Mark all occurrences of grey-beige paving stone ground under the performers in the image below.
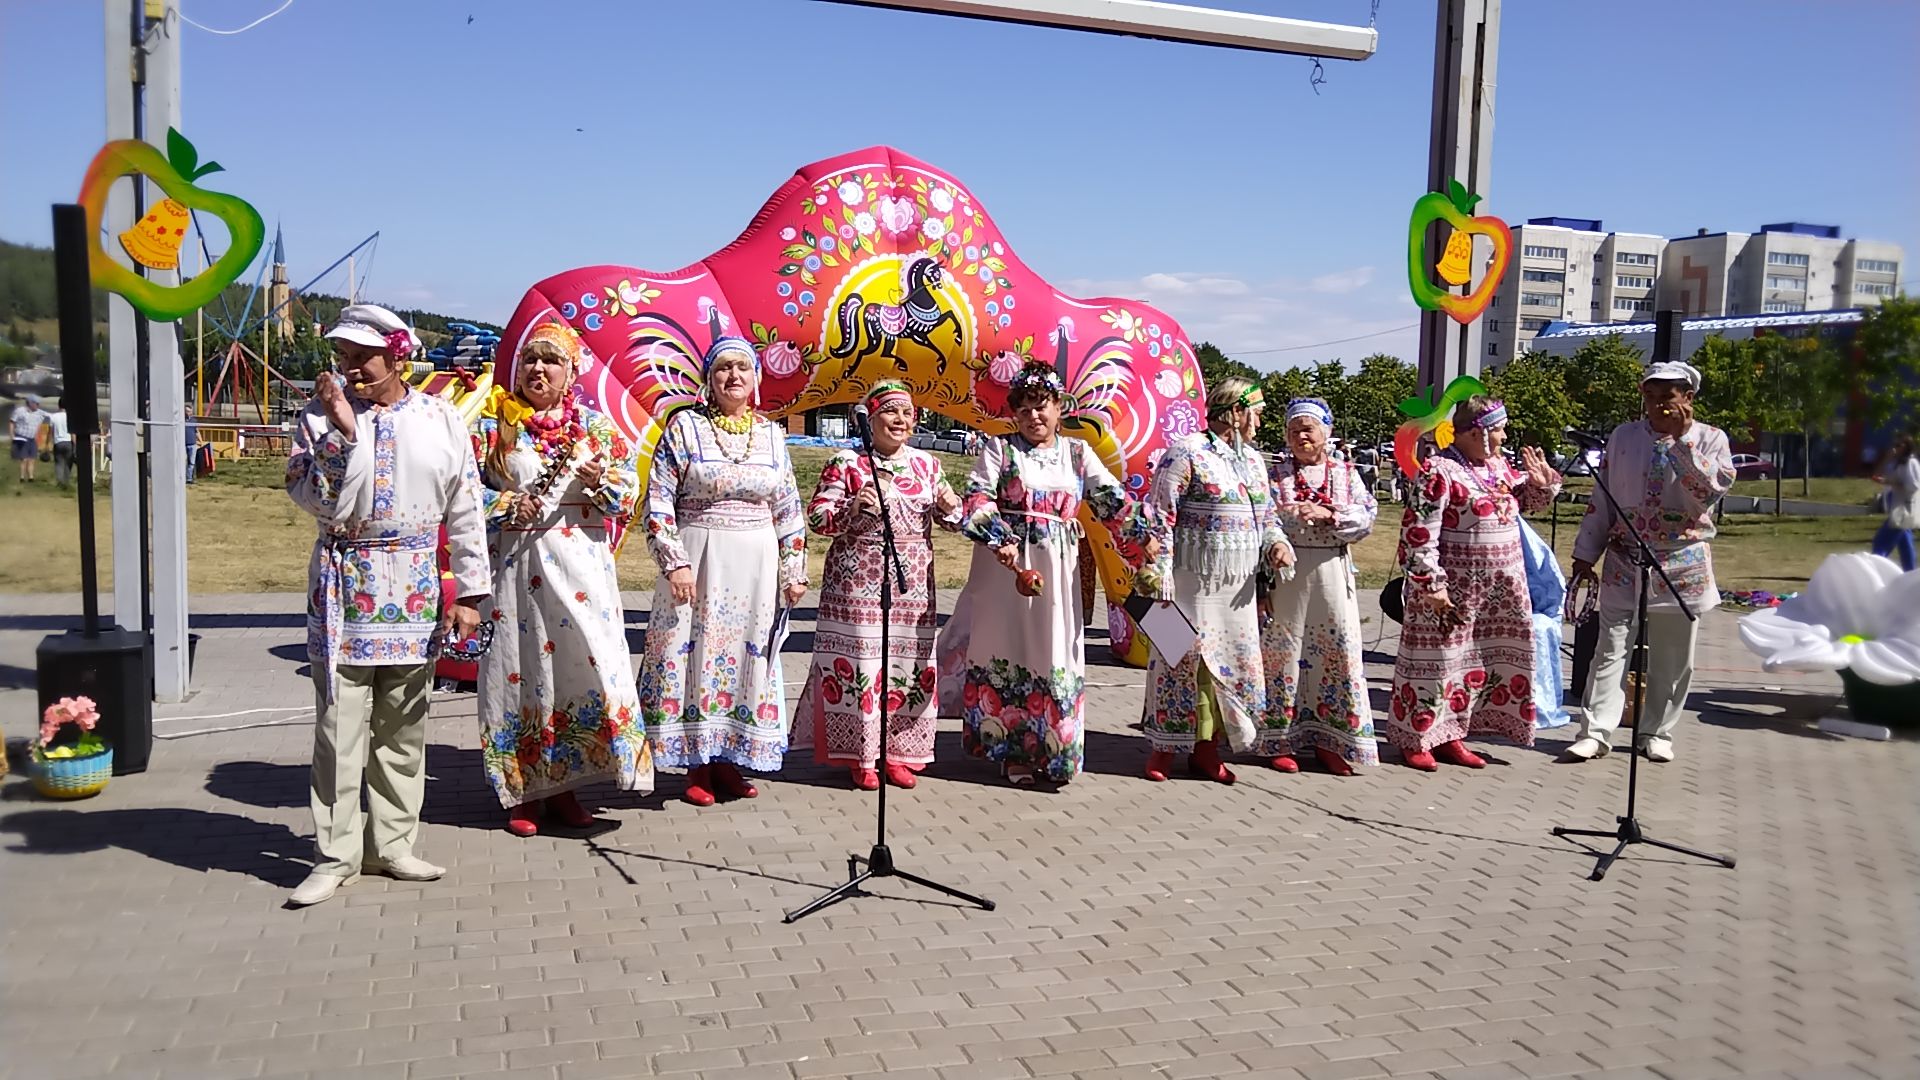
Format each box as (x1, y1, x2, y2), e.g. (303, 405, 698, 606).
(0, 596, 1920, 1080)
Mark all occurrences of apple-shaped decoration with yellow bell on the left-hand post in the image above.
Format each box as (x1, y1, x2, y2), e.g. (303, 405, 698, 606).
(81, 127, 267, 323)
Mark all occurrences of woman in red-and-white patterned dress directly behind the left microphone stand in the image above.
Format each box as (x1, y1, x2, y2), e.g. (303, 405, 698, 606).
(793, 380, 960, 792)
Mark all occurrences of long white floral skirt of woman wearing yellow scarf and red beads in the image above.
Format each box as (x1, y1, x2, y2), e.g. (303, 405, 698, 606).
(480, 525, 653, 807)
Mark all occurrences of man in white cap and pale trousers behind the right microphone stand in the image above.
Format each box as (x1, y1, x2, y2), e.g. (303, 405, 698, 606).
(1567, 361, 1734, 761)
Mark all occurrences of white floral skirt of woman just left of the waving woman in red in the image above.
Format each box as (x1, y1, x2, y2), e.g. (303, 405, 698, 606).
(1260, 548, 1380, 765)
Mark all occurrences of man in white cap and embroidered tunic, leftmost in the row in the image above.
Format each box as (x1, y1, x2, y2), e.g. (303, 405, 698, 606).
(286, 304, 493, 907)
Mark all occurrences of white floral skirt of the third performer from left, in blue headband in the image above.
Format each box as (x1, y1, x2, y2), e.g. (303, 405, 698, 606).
(639, 525, 787, 773)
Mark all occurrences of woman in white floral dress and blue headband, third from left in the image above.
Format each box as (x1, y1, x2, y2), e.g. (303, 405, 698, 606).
(639, 336, 806, 807)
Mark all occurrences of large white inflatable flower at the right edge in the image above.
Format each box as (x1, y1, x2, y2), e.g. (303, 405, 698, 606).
(1740, 555, 1920, 686)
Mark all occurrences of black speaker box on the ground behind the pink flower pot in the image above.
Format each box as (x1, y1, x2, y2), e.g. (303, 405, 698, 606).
(35, 626, 154, 776)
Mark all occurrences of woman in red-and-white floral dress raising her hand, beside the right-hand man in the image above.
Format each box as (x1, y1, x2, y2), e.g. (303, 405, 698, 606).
(1386, 394, 1561, 773)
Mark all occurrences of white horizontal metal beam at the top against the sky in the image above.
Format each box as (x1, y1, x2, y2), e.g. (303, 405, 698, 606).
(828, 0, 1380, 60)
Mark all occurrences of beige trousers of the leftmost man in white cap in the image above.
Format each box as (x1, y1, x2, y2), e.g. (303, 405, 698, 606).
(311, 663, 434, 876)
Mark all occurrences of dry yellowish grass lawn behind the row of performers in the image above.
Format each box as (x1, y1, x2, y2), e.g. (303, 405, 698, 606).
(0, 448, 1880, 592)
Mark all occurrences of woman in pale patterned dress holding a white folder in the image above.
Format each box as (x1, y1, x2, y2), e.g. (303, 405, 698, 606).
(1135, 377, 1294, 784)
